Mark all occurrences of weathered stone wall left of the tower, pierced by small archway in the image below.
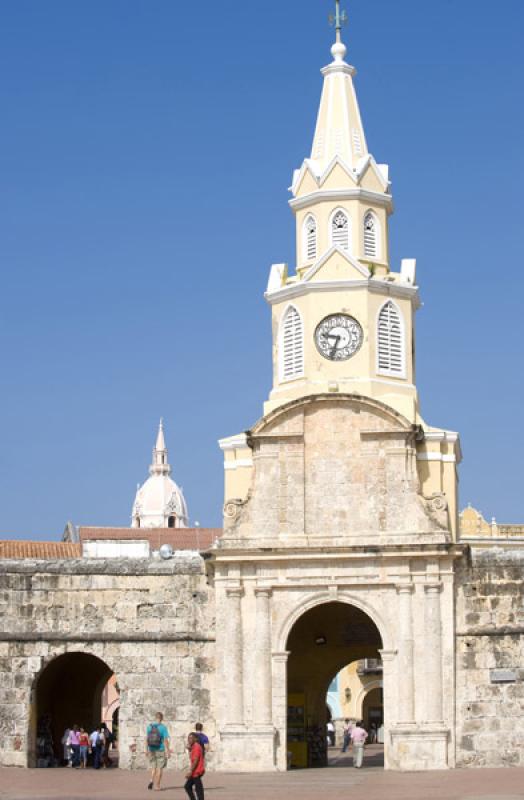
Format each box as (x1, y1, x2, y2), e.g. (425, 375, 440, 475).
(0, 554, 215, 768)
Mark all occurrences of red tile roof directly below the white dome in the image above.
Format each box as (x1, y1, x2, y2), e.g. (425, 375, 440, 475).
(79, 527, 222, 550)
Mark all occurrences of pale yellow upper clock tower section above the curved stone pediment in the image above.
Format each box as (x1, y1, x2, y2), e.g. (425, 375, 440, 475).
(264, 11, 419, 422)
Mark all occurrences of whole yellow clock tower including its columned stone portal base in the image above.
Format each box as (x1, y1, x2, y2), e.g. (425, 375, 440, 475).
(215, 0, 462, 770)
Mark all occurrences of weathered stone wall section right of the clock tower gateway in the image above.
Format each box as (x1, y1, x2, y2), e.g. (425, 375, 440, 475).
(456, 548, 524, 767)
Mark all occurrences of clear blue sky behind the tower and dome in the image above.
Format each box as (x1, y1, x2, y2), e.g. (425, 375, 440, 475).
(0, 0, 524, 539)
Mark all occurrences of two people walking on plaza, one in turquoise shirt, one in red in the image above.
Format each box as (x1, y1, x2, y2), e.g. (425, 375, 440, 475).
(146, 711, 209, 800)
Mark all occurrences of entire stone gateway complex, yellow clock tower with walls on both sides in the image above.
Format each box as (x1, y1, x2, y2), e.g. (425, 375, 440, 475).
(0, 6, 524, 771)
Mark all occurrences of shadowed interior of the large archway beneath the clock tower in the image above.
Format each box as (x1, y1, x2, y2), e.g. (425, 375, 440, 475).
(286, 601, 382, 767)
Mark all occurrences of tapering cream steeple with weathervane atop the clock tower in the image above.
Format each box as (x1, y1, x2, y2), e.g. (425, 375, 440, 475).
(311, 0, 368, 174)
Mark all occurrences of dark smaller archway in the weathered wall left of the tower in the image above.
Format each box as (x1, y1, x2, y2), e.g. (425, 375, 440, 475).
(28, 652, 116, 767)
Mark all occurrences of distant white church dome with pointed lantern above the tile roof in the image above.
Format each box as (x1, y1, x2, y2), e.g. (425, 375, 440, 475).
(131, 420, 188, 528)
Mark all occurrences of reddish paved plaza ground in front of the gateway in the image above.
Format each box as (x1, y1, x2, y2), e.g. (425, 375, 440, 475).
(0, 745, 524, 800)
